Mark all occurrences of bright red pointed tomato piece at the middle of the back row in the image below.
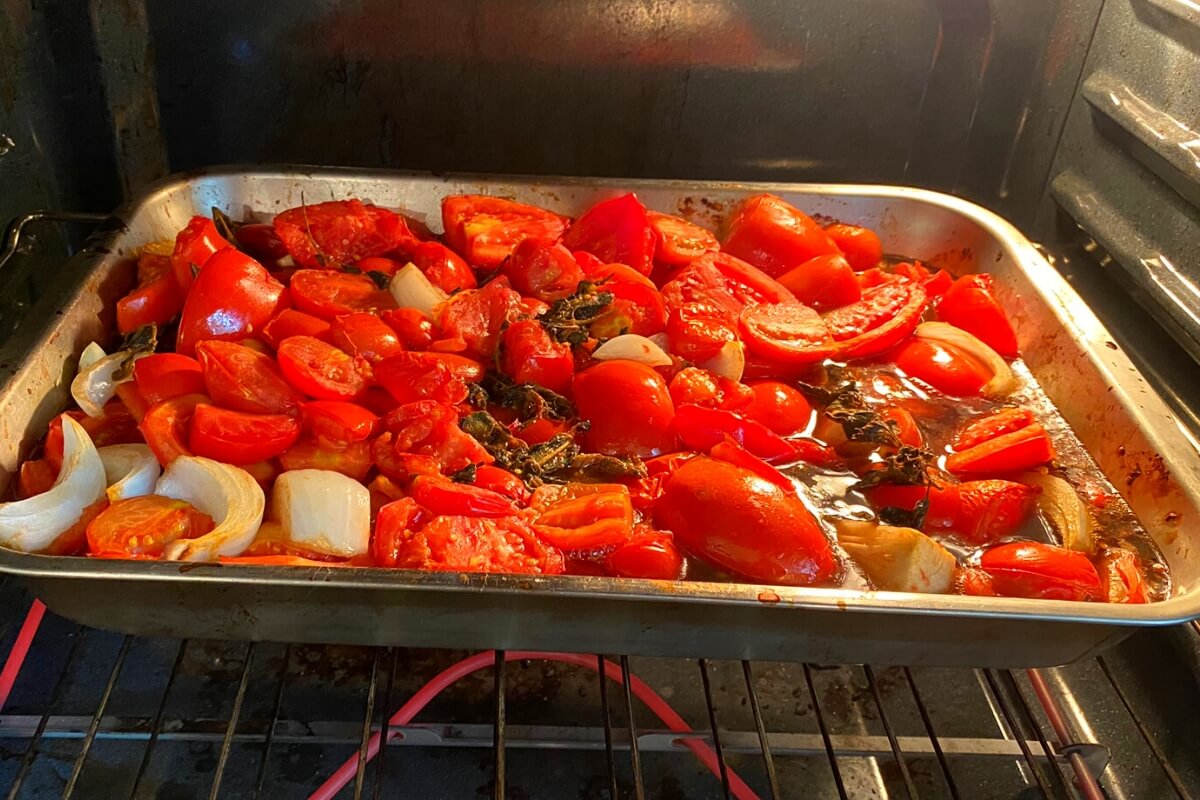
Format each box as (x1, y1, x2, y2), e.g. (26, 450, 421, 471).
(563, 193, 655, 275)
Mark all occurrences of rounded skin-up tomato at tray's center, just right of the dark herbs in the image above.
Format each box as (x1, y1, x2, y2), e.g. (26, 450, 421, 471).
(572, 360, 676, 458)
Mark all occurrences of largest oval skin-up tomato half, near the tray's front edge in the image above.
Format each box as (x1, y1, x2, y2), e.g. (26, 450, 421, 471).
(654, 456, 839, 585)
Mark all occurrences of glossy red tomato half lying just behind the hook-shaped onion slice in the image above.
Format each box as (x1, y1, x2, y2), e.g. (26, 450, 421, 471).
(187, 403, 300, 465)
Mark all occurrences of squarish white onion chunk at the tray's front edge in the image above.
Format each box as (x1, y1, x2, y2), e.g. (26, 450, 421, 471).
(271, 469, 371, 558)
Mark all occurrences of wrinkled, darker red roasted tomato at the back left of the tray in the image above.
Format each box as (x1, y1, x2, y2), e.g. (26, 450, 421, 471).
(274, 200, 416, 269)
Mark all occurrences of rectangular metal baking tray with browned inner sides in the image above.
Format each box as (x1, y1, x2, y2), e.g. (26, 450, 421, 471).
(0, 167, 1200, 667)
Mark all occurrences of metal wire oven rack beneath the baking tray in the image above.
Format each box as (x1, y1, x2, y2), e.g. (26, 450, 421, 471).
(0, 575, 1200, 800)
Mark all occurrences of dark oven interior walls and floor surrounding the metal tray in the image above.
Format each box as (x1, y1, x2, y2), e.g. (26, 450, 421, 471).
(0, 0, 1200, 799)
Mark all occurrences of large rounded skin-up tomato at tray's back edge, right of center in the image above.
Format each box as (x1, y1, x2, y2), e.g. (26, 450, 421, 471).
(722, 194, 839, 276)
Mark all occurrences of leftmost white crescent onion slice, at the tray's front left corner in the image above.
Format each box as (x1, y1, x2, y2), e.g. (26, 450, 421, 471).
(0, 414, 104, 553)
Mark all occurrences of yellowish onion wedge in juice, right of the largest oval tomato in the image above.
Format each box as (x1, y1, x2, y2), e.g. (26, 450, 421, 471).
(836, 519, 956, 594)
